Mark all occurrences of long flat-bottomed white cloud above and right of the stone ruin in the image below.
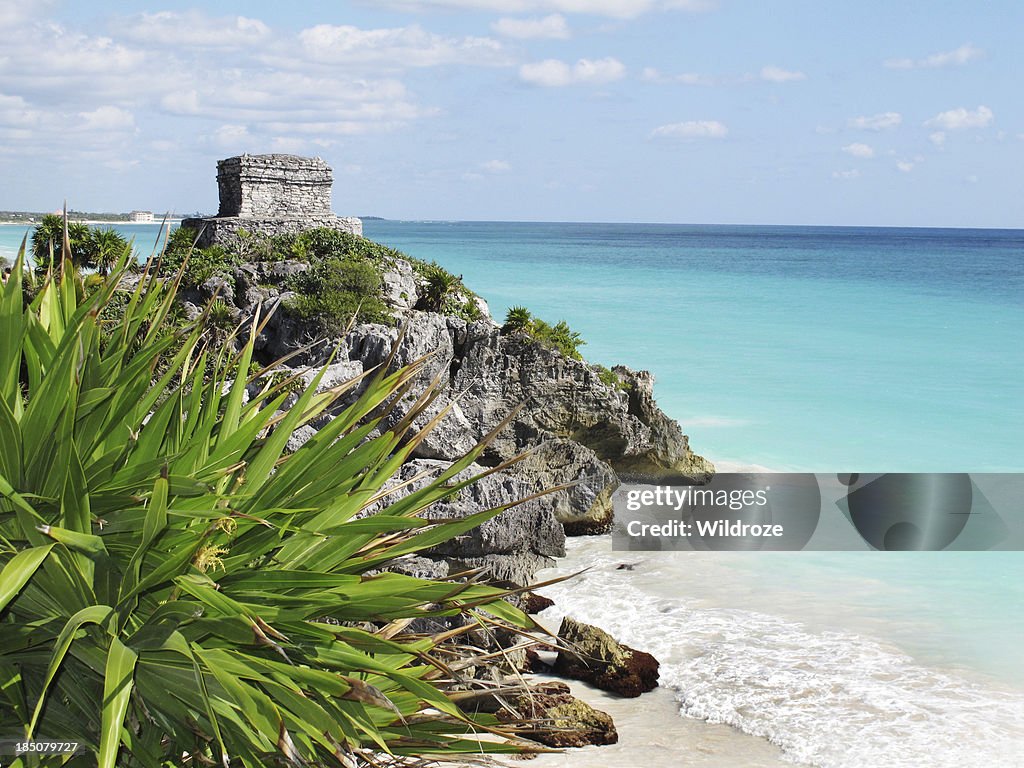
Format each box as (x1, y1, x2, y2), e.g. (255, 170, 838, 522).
(296, 24, 510, 69)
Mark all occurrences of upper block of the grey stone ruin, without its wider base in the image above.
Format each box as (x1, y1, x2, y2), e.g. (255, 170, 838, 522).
(217, 155, 334, 218)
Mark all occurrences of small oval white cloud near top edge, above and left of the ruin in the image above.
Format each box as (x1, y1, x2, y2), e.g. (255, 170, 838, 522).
(117, 10, 270, 49)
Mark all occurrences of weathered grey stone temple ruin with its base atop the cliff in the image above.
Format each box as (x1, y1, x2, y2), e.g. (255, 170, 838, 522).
(181, 155, 362, 248)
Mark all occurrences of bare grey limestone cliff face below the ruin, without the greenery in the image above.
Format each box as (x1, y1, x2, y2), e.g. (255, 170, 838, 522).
(217, 243, 714, 585)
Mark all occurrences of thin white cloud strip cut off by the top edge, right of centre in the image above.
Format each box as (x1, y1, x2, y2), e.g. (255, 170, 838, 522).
(368, 0, 716, 18)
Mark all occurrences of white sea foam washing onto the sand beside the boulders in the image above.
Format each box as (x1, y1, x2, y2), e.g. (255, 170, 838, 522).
(540, 540, 1024, 768)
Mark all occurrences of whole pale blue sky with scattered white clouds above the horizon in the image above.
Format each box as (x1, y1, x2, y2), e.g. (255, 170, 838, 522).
(0, 0, 1024, 227)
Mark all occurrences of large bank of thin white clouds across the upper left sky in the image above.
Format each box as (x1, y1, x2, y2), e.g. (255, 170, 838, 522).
(0, 12, 468, 158)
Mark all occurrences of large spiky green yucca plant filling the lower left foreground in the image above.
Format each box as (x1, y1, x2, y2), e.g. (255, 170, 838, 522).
(0, 236, 534, 768)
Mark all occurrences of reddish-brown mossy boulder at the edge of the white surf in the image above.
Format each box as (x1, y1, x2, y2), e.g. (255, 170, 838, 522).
(554, 616, 658, 698)
